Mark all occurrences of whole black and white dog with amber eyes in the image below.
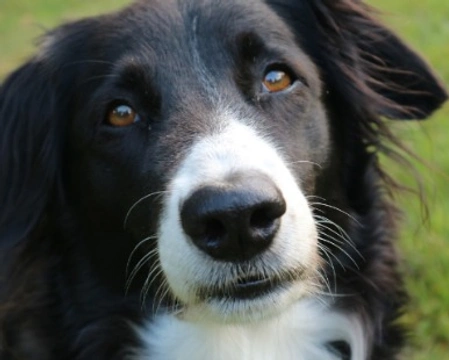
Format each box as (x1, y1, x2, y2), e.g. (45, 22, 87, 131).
(0, 0, 447, 360)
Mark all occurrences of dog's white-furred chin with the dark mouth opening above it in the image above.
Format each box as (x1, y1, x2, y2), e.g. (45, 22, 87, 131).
(179, 279, 314, 324)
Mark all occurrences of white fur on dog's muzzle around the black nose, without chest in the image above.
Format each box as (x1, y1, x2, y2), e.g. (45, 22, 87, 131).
(158, 117, 319, 321)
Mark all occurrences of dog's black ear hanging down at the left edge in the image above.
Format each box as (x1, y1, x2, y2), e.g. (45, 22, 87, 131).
(0, 18, 95, 249)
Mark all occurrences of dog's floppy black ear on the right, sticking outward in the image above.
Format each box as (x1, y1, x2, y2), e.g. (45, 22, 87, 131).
(310, 0, 447, 119)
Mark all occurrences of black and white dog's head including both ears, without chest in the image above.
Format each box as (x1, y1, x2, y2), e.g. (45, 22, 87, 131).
(0, 0, 446, 319)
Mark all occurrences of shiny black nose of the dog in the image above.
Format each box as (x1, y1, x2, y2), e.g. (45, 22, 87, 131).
(181, 174, 286, 261)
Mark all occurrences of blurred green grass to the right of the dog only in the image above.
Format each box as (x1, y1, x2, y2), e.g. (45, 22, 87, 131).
(370, 0, 449, 360)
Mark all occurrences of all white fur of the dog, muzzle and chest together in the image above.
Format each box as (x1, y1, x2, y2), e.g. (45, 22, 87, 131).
(135, 116, 367, 360)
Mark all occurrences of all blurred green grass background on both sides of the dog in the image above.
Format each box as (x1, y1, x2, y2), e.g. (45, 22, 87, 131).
(0, 0, 449, 360)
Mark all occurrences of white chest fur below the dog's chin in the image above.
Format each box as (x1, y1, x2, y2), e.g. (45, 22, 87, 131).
(133, 301, 367, 360)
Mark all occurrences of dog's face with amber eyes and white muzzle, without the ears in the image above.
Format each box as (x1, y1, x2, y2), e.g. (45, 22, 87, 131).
(68, 1, 331, 319)
